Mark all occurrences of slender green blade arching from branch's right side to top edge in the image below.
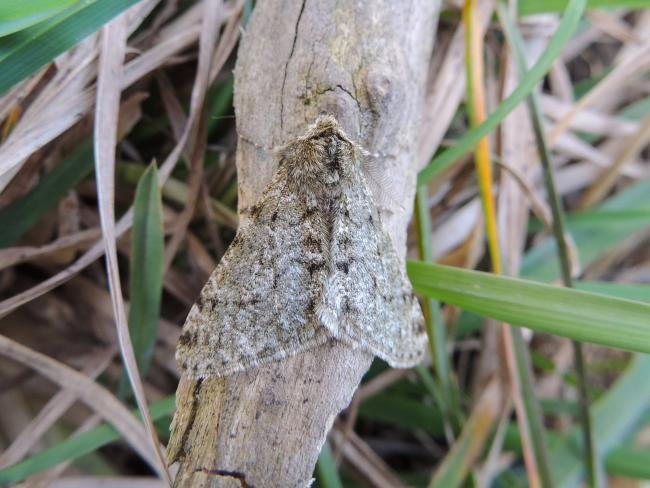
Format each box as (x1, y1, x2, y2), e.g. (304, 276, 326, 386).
(418, 0, 586, 185)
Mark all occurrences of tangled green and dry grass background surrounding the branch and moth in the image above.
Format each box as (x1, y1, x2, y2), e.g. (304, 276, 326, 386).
(0, 0, 650, 487)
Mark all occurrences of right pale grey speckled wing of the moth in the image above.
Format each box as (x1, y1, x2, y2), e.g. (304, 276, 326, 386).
(324, 174, 426, 367)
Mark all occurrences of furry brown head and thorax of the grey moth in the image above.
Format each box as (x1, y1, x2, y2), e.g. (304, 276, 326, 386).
(279, 115, 359, 184)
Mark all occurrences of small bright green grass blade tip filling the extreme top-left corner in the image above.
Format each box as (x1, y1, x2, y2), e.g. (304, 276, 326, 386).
(0, 0, 79, 37)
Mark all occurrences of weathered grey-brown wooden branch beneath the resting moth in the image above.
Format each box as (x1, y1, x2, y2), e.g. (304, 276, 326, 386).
(168, 0, 438, 488)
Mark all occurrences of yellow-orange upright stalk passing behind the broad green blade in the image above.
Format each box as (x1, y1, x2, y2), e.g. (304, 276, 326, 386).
(462, 0, 553, 488)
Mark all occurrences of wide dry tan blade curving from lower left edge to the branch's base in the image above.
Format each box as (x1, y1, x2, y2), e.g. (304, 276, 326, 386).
(0, 335, 159, 476)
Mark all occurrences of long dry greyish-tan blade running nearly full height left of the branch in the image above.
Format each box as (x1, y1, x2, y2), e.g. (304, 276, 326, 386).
(94, 10, 171, 485)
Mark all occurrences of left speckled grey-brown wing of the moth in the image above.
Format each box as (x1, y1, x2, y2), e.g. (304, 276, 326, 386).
(176, 178, 331, 377)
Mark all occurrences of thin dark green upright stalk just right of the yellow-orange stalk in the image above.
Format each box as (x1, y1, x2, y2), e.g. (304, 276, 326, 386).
(497, 2, 599, 487)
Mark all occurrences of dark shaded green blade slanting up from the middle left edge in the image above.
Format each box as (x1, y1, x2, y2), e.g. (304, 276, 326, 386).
(0, 140, 93, 248)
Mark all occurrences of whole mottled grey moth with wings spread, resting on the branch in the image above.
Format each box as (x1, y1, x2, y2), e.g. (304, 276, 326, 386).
(176, 116, 426, 378)
